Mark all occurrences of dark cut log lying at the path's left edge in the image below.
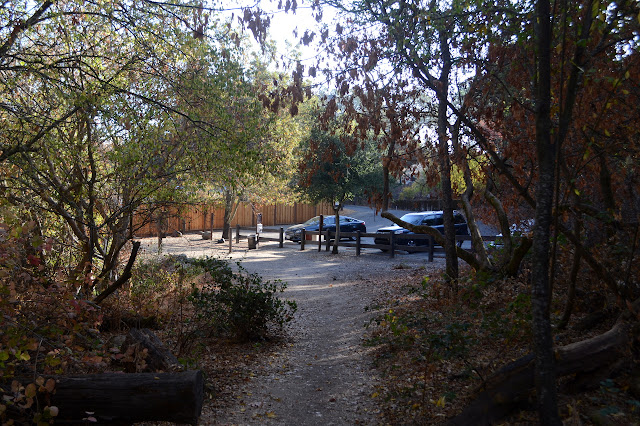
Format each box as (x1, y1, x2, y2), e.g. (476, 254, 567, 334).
(49, 370, 204, 424)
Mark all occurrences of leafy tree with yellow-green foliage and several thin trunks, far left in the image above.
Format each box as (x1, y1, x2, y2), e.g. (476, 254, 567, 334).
(0, 1, 284, 295)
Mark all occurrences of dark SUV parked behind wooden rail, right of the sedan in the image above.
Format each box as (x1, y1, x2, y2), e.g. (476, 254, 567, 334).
(374, 211, 469, 251)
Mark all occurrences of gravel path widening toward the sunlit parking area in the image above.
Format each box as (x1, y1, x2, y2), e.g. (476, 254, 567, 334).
(138, 209, 444, 425)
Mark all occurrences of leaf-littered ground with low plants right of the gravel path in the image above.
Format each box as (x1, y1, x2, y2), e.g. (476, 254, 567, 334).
(366, 270, 640, 425)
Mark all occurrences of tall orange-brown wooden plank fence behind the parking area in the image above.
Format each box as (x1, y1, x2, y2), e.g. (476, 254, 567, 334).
(133, 202, 333, 237)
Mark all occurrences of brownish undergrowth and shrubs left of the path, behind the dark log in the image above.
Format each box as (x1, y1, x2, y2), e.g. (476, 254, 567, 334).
(0, 223, 296, 424)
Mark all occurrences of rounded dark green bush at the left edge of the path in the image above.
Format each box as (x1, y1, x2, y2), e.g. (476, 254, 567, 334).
(189, 258, 297, 340)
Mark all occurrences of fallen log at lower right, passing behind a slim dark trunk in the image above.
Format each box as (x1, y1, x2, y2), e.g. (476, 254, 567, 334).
(448, 321, 632, 426)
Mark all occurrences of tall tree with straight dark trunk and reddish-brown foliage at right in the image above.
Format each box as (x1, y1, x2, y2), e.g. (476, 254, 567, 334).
(308, 1, 640, 422)
